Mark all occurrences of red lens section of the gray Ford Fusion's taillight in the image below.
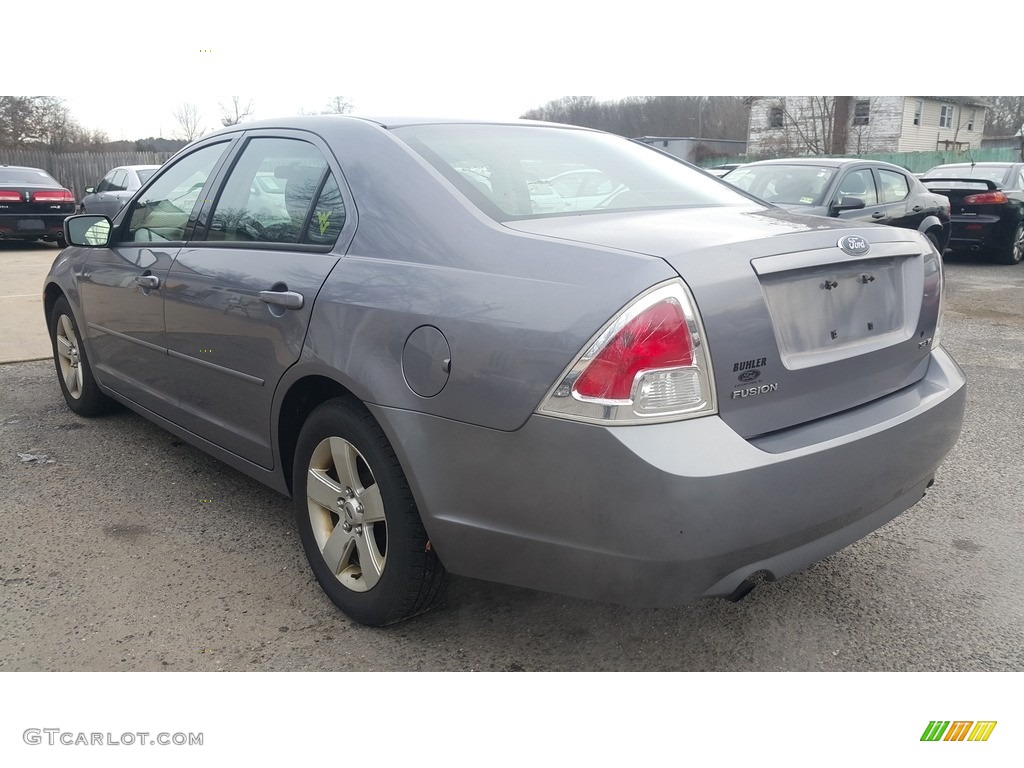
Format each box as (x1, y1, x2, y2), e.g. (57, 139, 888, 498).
(572, 301, 693, 400)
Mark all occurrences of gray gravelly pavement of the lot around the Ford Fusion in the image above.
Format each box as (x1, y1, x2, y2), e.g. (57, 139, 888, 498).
(0, 248, 1024, 671)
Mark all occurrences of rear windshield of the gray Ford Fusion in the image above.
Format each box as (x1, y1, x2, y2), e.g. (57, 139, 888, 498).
(394, 125, 752, 221)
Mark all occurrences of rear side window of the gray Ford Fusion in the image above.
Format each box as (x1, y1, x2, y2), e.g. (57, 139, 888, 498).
(207, 137, 345, 245)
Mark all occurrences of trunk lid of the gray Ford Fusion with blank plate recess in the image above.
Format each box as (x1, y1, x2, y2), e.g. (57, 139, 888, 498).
(507, 208, 941, 437)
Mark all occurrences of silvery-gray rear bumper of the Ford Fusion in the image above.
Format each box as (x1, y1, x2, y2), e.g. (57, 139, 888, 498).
(375, 349, 966, 606)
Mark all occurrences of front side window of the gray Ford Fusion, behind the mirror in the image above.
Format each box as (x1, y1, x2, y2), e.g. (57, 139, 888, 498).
(124, 141, 227, 243)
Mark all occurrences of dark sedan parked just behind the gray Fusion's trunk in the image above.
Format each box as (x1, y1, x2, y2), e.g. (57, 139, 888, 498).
(723, 158, 949, 253)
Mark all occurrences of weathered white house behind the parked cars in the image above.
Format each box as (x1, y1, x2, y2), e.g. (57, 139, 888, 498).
(746, 96, 987, 157)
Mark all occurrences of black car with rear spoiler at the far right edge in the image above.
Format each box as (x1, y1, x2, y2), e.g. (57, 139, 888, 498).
(921, 163, 1024, 264)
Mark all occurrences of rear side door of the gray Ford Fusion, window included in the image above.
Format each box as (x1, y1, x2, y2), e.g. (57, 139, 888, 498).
(165, 131, 354, 467)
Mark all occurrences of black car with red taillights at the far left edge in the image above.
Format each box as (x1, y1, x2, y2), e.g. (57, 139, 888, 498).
(0, 165, 75, 247)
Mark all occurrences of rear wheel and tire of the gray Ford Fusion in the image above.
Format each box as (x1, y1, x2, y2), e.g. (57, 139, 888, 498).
(292, 398, 449, 627)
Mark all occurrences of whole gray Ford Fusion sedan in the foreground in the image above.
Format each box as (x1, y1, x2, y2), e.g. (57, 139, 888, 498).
(44, 116, 966, 625)
